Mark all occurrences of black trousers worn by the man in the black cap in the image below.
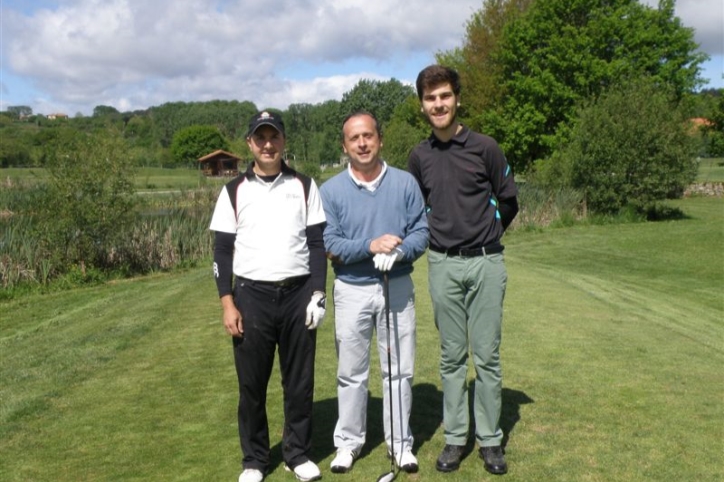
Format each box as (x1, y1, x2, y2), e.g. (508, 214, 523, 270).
(233, 278, 317, 473)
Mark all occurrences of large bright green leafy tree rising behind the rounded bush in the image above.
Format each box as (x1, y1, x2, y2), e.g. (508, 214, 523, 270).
(472, 0, 706, 173)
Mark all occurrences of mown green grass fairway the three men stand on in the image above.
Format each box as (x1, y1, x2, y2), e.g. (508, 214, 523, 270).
(0, 198, 724, 482)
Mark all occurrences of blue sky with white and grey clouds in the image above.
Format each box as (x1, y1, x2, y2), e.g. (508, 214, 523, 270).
(0, 0, 724, 116)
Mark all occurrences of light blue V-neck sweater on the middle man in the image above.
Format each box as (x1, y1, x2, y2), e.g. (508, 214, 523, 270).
(320, 166, 429, 283)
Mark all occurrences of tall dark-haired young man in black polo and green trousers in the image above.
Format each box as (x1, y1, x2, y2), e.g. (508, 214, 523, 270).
(408, 65, 518, 474)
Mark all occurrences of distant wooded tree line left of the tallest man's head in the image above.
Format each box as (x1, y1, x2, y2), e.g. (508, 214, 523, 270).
(0, 79, 415, 173)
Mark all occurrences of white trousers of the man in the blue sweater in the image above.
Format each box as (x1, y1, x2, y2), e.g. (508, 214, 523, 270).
(334, 275, 415, 453)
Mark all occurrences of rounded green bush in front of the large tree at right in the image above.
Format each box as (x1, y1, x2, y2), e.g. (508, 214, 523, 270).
(560, 79, 697, 213)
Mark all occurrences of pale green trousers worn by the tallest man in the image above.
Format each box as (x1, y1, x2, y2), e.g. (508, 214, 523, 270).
(428, 251, 508, 447)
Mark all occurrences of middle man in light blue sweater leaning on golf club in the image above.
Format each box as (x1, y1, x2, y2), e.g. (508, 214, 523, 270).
(321, 112, 429, 473)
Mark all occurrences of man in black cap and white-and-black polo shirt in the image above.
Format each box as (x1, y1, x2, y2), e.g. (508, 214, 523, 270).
(209, 112, 327, 482)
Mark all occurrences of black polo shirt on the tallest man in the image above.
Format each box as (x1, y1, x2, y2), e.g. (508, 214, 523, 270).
(408, 126, 518, 250)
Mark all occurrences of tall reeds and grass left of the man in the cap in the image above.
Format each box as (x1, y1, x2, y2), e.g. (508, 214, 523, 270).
(0, 183, 218, 296)
